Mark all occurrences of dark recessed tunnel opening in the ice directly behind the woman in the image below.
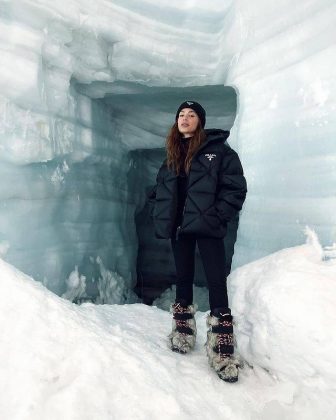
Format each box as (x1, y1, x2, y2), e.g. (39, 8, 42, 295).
(86, 86, 238, 304)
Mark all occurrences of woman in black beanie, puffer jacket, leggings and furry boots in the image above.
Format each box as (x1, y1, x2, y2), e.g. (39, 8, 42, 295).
(151, 101, 247, 382)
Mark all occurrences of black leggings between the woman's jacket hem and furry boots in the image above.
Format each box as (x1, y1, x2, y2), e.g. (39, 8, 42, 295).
(171, 236, 229, 311)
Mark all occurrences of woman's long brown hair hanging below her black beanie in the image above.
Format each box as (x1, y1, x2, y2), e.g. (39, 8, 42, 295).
(166, 122, 206, 175)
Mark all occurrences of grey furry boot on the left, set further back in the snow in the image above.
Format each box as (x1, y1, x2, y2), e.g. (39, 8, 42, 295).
(168, 302, 197, 353)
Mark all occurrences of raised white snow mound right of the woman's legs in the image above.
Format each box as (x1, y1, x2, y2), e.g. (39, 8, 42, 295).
(229, 230, 336, 416)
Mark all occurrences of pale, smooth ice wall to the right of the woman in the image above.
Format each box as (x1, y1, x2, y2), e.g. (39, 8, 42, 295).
(225, 0, 336, 265)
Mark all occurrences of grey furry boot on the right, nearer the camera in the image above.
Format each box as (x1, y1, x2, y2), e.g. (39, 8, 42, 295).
(205, 308, 242, 382)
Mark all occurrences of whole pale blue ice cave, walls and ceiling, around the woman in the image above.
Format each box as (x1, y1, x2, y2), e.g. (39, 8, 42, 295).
(0, 0, 336, 300)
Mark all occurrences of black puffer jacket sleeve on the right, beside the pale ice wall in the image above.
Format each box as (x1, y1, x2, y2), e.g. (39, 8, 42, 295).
(215, 149, 247, 222)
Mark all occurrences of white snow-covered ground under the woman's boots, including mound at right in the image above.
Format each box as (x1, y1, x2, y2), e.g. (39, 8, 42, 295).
(0, 233, 336, 420)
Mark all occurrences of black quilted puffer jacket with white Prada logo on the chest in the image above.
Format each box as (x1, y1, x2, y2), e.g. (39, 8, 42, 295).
(150, 130, 247, 239)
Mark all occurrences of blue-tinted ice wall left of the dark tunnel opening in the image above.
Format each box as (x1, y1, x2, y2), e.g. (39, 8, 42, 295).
(0, 87, 136, 293)
